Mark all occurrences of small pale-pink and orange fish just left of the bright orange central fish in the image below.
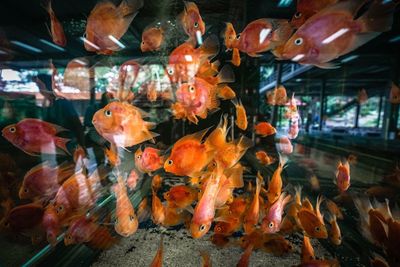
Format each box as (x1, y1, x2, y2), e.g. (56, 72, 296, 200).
(135, 146, 165, 174)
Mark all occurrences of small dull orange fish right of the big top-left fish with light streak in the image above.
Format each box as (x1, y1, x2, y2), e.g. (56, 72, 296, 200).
(140, 23, 165, 52)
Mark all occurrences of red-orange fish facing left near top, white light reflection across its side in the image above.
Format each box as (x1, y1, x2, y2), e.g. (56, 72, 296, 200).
(234, 18, 293, 57)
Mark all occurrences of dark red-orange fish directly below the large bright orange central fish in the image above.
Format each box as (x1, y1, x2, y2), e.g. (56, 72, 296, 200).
(163, 185, 197, 209)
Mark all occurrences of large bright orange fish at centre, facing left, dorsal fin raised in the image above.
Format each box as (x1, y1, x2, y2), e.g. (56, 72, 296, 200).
(164, 129, 215, 177)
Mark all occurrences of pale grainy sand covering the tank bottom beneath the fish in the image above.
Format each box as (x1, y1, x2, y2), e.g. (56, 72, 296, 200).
(92, 228, 332, 267)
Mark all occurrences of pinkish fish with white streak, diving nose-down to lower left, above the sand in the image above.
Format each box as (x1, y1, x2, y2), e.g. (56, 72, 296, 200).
(261, 193, 291, 234)
